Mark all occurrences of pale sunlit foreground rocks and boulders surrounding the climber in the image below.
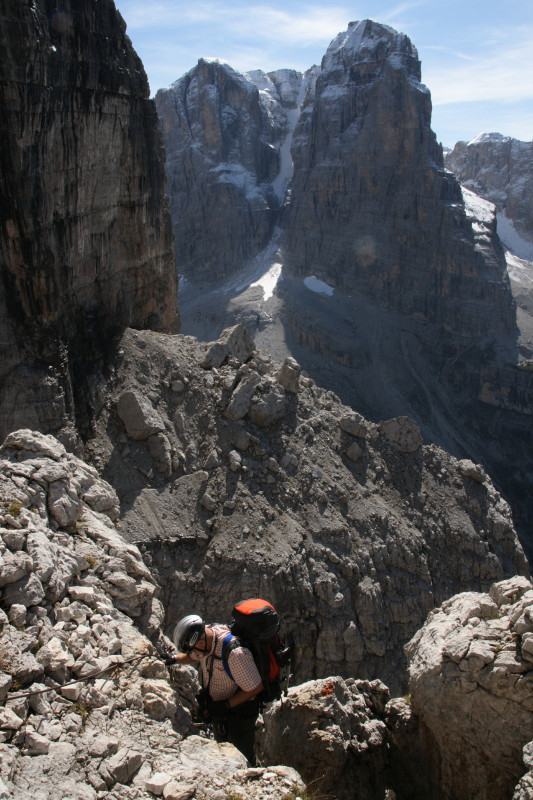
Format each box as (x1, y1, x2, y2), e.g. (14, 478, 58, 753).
(0, 430, 533, 800)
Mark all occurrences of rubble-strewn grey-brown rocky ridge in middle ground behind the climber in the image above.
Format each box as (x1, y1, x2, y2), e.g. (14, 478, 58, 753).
(81, 328, 527, 691)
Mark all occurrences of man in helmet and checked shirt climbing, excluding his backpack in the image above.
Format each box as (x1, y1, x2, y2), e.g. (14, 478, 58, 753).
(166, 614, 263, 766)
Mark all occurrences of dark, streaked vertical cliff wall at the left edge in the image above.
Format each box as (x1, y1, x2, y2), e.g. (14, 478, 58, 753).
(0, 0, 178, 446)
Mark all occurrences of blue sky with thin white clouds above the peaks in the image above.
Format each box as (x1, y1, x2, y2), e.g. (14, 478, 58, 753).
(115, 0, 533, 146)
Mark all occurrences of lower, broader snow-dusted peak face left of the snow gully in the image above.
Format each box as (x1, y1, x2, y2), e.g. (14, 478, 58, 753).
(156, 59, 286, 282)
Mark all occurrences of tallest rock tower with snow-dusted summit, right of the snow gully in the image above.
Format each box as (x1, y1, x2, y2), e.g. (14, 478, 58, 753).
(285, 20, 514, 338)
